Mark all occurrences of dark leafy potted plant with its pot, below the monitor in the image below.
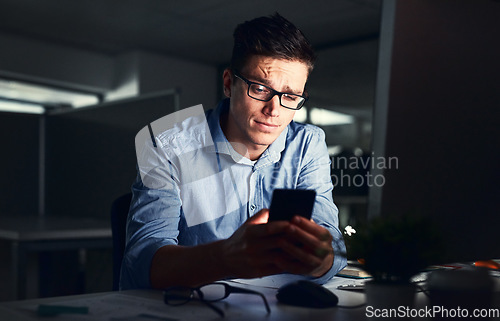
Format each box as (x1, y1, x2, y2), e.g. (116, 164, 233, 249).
(345, 216, 440, 307)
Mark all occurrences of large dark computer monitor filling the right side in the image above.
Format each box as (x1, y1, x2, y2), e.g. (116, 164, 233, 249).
(368, 1, 500, 262)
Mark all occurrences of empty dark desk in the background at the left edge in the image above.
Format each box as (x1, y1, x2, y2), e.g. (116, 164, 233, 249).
(0, 216, 112, 299)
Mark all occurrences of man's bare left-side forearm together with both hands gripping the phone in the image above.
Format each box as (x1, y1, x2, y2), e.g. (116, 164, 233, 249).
(150, 209, 333, 289)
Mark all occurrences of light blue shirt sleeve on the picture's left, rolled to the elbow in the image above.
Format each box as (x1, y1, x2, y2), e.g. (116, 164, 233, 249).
(120, 126, 182, 290)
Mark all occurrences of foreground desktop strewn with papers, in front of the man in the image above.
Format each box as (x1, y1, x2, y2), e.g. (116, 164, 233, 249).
(0, 270, 500, 321)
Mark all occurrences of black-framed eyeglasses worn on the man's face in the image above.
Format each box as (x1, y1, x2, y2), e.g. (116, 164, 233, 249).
(233, 71, 308, 110)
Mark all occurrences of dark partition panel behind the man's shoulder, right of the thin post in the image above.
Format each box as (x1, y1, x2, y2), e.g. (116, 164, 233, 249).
(45, 91, 177, 217)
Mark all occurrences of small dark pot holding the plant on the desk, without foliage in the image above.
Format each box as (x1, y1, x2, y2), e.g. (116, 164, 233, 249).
(365, 281, 416, 320)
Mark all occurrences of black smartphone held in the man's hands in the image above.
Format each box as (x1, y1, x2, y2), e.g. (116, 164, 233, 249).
(269, 189, 316, 222)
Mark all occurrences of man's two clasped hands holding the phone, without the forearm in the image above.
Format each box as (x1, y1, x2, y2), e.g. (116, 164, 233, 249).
(218, 209, 333, 278)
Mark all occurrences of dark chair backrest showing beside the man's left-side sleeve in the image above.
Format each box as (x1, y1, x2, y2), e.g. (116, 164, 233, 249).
(111, 193, 132, 291)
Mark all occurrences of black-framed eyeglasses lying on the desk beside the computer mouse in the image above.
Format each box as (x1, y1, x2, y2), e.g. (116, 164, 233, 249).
(163, 282, 271, 317)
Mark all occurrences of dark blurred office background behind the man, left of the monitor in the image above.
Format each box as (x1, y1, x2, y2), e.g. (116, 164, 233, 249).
(0, 0, 380, 300)
